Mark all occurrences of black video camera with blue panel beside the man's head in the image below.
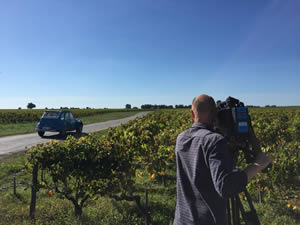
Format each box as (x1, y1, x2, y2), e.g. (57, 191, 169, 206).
(215, 96, 261, 163)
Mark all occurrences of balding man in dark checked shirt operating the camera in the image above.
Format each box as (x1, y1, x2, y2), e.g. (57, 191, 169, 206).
(174, 94, 272, 225)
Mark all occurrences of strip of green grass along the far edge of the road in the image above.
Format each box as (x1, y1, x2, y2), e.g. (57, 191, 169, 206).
(0, 111, 140, 137)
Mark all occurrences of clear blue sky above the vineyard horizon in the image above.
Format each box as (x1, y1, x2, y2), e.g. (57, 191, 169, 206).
(0, 0, 300, 108)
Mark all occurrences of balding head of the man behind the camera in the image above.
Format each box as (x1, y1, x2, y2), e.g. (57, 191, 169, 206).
(191, 94, 216, 125)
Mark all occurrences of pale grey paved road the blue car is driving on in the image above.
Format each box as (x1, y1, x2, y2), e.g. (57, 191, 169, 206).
(0, 112, 148, 158)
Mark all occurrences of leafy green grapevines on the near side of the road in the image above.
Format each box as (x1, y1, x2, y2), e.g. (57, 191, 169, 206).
(0, 107, 300, 224)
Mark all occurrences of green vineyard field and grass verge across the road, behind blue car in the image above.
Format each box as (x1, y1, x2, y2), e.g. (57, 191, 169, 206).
(0, 109, 140, 137)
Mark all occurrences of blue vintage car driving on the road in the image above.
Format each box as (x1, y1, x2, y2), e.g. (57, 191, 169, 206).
(35, 110, 83, 137)
